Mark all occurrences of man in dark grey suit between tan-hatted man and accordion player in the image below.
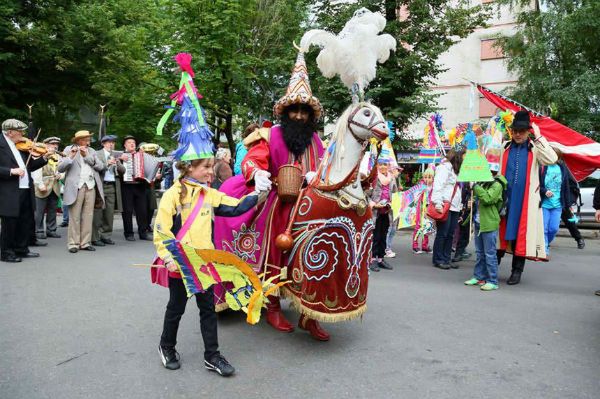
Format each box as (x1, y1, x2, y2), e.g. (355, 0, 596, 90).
(92, 135, 125, 247)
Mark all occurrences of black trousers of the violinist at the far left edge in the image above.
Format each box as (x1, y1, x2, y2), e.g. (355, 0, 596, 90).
(0, 189, 35, 256)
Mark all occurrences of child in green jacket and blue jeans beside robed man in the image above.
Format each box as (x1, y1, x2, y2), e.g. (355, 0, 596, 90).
(465, 162, 507, 291)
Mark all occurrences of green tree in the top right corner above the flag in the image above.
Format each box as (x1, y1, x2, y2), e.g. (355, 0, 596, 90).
(501, 0, 600, 139)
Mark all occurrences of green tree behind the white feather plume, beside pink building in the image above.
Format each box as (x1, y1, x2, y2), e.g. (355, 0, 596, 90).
(311, 0, 487, 131)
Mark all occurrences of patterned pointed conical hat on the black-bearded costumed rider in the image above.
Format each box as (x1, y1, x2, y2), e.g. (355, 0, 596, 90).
(273, 52, 323, 119)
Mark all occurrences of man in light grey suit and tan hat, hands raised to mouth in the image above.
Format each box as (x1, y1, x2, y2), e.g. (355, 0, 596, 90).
(58, 130, 106, 253)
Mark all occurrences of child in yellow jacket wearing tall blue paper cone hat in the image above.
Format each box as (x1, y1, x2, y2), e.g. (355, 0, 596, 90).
(152, 53, 266, 376)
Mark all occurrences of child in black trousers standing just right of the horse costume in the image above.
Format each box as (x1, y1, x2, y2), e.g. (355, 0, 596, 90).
(369, 159, 398, 272)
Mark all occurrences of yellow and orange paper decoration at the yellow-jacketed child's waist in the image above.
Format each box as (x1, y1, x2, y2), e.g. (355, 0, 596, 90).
(158, 231, 287, 324)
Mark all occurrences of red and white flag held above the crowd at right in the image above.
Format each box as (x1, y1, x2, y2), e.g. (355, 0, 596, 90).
(477, 84, 600, 181)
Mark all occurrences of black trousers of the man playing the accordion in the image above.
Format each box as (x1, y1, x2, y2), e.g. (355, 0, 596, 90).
(121, 183, 148, 237)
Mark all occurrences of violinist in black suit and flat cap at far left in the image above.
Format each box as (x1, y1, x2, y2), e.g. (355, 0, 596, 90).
(0, 119, 53, 263)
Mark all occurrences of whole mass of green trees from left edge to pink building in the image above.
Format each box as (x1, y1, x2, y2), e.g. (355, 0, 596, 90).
(0, 0, 485, 150)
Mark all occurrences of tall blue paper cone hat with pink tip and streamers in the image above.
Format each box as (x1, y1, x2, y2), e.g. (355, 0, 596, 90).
(156, 53, 214, 161)
